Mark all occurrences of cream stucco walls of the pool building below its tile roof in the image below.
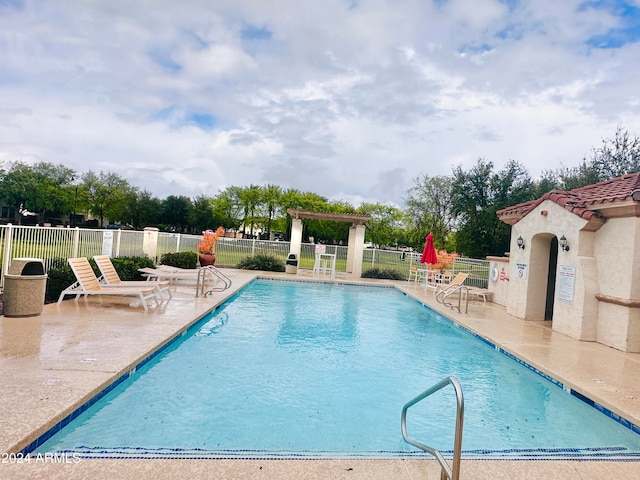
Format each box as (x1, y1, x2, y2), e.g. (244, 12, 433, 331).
(502, 193, 640, 352)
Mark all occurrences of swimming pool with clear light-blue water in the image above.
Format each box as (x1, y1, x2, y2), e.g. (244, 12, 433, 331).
(36, 281, 640, 458)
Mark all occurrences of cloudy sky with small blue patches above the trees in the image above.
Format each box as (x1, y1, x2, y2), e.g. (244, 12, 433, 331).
(0, 0, 640, 206)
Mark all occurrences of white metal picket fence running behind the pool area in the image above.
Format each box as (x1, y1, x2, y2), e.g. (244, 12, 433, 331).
(0, 225, 489, 287)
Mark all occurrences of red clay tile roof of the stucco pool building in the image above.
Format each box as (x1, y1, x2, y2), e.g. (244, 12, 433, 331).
(496, 173, 640, 224)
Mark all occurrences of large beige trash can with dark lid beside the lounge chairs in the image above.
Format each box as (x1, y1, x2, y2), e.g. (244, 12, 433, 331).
(3, 258, 47, 317)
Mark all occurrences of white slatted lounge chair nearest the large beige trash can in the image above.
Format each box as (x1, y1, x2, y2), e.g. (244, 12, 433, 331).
(58, 257, 160, 312)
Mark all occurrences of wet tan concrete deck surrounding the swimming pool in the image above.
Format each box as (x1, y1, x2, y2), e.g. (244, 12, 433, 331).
(0, 269, 640, 480)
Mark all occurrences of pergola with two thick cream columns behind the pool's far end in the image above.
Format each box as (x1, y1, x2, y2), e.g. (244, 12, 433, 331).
(287, 208, 371, 277)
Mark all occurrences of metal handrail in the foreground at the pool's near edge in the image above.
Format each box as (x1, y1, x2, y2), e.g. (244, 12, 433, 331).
(400, 377, 464, 480)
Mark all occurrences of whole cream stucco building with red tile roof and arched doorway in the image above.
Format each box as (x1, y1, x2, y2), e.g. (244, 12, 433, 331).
(489, 173, 640, 352)
